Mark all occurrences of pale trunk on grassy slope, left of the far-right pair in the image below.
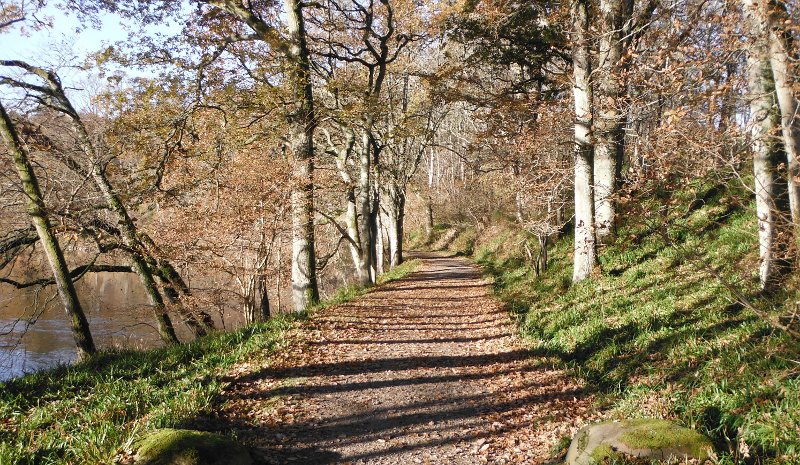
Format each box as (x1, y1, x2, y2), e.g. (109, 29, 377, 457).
(744, 0, 791, 291)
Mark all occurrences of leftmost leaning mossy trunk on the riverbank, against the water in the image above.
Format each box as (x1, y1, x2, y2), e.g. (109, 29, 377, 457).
(0, 104, 96, 360)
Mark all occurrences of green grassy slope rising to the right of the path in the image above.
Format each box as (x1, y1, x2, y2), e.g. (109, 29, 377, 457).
(418, 187, 800, 464)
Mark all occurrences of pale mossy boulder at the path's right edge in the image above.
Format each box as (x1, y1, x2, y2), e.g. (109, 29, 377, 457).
(566, 419, 713, 465)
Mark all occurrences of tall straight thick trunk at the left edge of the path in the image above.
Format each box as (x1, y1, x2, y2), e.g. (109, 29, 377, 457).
(286, 0, 319, 312)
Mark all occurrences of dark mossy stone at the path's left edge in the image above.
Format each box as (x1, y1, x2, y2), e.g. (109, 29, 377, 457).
(134, 429, 253, 465)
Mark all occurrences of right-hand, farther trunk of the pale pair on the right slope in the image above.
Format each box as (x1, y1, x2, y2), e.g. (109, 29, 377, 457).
(593, 0, 632, 243)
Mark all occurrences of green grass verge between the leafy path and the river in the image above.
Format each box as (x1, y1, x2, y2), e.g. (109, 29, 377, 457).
(0, 261, 417, 465)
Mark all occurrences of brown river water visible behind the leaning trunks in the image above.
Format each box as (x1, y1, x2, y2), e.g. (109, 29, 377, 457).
(0, 273, 238, 381)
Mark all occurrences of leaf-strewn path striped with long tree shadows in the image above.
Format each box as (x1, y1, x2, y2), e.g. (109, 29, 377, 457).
(209, 254, 596, 465)
